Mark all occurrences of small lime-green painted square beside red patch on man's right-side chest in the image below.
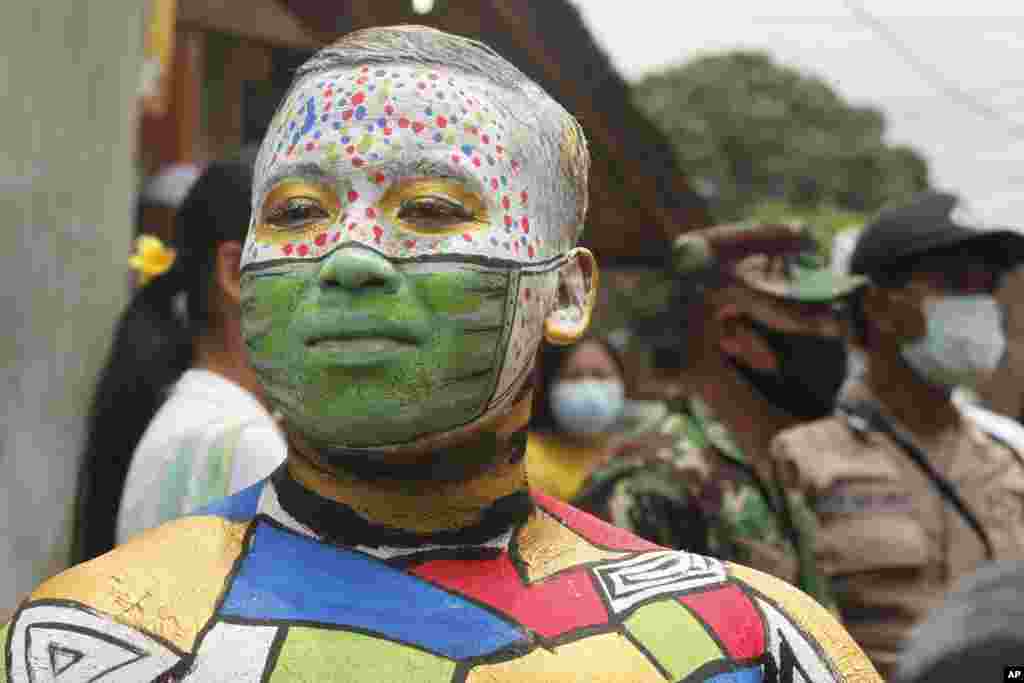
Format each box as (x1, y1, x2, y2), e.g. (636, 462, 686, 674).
(626, 599, 724, 680)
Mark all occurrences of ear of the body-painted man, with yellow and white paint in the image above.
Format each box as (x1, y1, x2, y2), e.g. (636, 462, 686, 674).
(544, 247, 599, 346)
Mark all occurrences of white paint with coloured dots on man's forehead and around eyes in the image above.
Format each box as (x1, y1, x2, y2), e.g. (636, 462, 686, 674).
(244, 66, 572, 265)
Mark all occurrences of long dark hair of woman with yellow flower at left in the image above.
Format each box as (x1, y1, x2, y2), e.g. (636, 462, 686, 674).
(73, 150, 254, 562)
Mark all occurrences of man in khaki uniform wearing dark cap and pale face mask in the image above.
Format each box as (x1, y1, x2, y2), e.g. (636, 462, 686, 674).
(772, 194, 1024, 675)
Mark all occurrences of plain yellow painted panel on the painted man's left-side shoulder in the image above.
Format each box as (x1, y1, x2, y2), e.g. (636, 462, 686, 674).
(24, 515, 249, 650)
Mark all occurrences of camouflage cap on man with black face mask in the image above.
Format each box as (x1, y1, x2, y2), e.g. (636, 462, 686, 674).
(672, 223, 867, 303)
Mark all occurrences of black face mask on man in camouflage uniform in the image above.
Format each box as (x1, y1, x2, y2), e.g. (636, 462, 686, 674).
(726, 317, 847, 420)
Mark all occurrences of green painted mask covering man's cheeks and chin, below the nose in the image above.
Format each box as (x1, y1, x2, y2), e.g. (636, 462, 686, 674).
(242, 255, 510, 447)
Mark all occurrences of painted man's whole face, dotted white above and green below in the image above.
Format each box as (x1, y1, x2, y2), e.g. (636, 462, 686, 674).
(242, 62, 575, 449)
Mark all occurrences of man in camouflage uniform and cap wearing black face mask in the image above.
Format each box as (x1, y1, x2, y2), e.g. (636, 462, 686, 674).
(574, 225, 863, 604)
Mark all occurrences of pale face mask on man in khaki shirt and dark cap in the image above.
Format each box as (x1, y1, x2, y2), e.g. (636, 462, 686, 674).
(900, 294, 1007, 388)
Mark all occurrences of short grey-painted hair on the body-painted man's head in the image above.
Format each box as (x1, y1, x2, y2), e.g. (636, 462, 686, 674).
(264, 26, 590, 243)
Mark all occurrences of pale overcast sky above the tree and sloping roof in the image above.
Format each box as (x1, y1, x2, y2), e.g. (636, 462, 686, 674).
(573, 0, 1024, 227)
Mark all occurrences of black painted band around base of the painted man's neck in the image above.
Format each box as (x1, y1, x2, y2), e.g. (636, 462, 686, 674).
(270, 465, 534, 548)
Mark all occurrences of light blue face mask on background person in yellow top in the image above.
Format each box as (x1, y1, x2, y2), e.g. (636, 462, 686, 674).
(550, 379, 626, 435)
